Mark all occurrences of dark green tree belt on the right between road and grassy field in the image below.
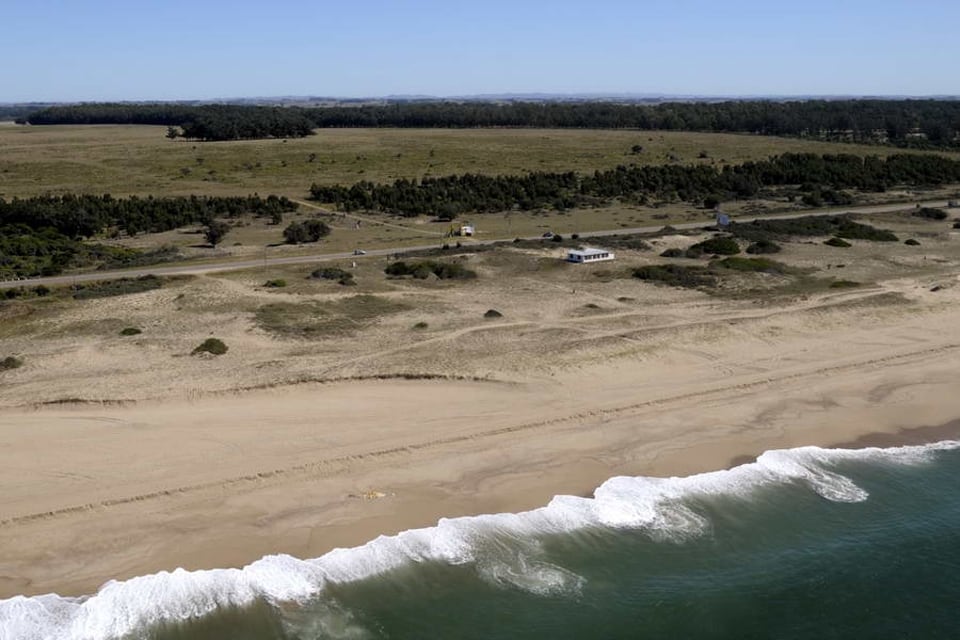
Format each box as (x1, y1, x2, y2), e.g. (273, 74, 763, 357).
(310, 154, 960, 219)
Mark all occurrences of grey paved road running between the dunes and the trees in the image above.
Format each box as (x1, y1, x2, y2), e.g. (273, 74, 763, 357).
(0, 200, 947, 289)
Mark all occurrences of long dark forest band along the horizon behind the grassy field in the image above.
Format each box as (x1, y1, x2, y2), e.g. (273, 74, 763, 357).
(22, 100, 960, 148)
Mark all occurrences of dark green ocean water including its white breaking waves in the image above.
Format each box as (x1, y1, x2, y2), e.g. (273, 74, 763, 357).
(0, 442, 960, 640)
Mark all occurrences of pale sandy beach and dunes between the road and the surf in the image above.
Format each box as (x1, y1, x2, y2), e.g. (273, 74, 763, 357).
(0, 214, 960, 597)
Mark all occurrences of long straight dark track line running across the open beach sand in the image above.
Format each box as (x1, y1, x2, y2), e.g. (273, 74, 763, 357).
(0, 343, 960, 527)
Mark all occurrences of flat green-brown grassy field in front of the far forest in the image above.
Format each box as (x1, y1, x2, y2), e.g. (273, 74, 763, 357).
(0, 123, 960, 198)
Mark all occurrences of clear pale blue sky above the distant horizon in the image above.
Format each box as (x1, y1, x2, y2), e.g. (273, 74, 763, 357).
(0, 0, 960, 102)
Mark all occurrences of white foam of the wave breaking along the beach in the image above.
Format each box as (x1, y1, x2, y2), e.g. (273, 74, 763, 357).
(0, 441, 960, 640)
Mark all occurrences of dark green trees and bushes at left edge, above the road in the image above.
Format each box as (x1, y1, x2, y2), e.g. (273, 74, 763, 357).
(0, 195, 297, 278)
